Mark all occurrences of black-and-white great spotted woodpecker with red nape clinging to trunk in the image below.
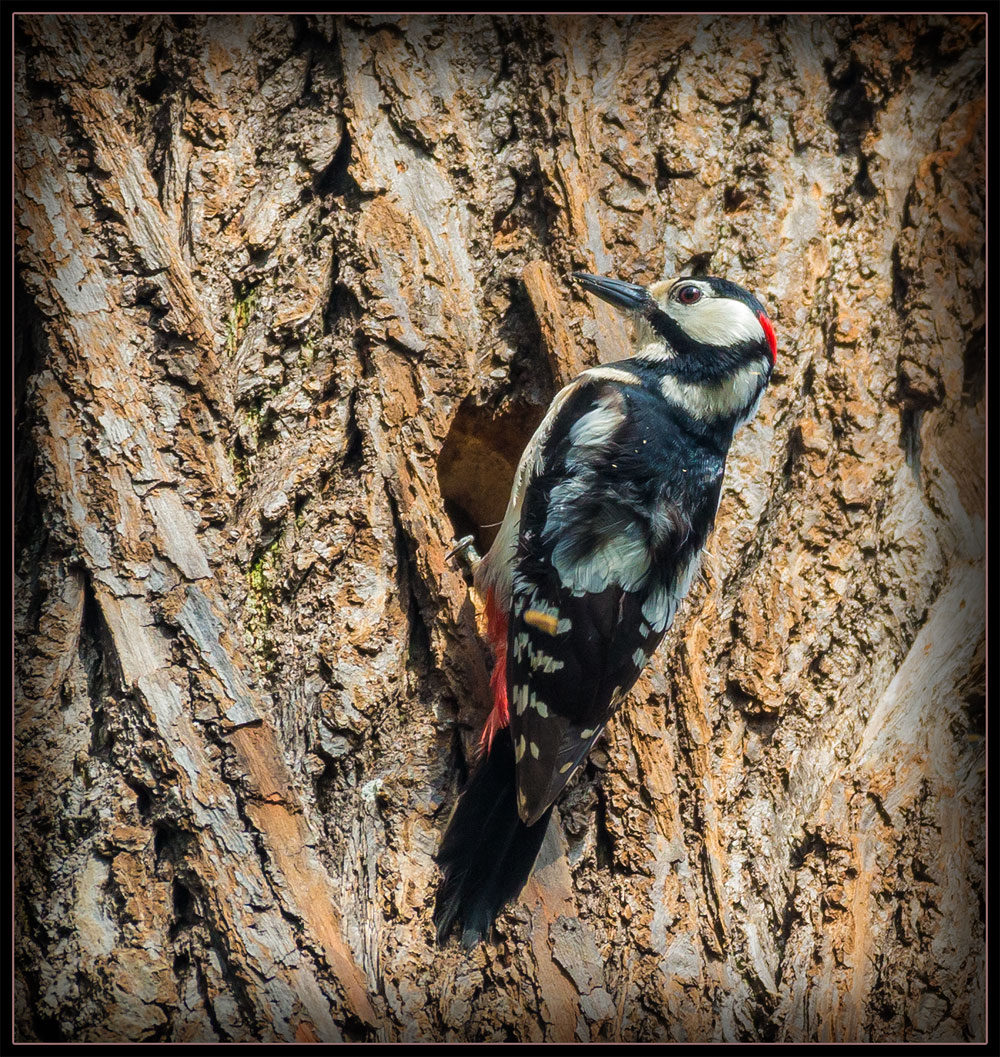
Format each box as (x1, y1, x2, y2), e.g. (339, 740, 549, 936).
(434, 273, 777, 946)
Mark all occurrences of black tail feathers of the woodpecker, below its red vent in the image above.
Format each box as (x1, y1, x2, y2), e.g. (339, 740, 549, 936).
(434, 728, 552, 947)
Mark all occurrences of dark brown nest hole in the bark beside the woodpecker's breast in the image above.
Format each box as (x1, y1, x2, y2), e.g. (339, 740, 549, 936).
(438, 396, 544, 554)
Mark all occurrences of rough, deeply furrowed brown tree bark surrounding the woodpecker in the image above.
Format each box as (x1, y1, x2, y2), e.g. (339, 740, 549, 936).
(15, 17, 985, 1040)
